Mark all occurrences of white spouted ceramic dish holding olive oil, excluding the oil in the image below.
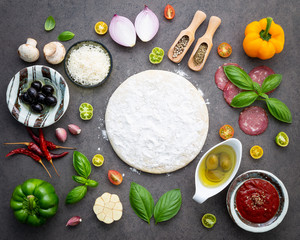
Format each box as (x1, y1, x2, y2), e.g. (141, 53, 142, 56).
(193, 138, 242, 203)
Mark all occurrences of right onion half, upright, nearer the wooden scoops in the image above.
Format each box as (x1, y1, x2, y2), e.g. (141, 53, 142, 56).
(134, 5, 159, 42)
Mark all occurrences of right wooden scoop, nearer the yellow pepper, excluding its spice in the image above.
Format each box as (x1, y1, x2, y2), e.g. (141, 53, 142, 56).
(188, 16, 221, 72)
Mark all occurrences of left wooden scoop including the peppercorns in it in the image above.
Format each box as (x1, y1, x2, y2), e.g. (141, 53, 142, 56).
(168, 10, 206, 63)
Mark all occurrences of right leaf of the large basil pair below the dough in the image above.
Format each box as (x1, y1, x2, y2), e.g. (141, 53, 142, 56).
(154, 189, 182, 223)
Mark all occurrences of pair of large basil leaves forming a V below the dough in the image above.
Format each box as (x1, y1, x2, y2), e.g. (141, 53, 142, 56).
(129, 182, 182, 224)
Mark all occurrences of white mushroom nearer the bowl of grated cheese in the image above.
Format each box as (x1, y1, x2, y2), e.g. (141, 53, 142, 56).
(44, 42, 66, 64)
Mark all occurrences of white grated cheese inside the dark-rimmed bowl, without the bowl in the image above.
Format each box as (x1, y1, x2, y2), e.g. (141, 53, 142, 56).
(67, 45, 110, 85)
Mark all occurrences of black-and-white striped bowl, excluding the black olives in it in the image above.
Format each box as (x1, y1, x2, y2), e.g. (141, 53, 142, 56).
(6, 65, 70, 128)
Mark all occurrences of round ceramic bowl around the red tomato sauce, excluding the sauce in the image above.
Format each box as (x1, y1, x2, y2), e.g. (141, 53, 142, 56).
(226, 170, 289, 233)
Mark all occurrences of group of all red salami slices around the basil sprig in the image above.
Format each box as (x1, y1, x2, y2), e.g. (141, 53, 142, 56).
(215, 63, 275, 136)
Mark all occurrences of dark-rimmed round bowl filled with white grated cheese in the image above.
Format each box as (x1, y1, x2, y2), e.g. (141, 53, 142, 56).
(64, 40, 112, 88)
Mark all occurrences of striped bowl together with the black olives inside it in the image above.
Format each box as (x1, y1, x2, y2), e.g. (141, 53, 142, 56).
(6, 65, 70, 128)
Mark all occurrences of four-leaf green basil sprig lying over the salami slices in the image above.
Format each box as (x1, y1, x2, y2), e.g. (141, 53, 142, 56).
(223, 65, 292, 123)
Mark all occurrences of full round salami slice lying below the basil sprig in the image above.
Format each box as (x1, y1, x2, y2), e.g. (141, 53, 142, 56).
(239, 106, 269, 136)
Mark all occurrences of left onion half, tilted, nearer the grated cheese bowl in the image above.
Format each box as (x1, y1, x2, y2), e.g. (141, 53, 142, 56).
(109, 14, 136, 47)
